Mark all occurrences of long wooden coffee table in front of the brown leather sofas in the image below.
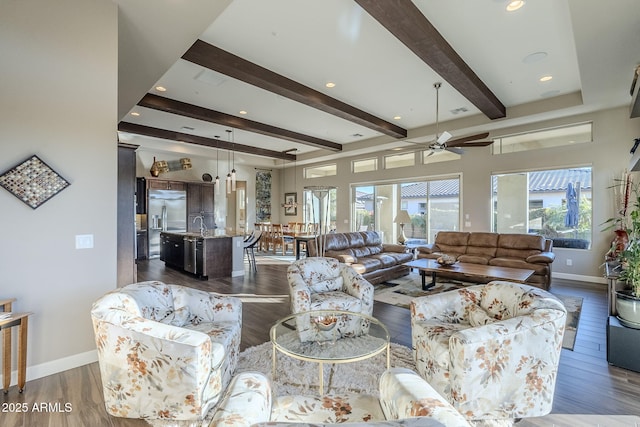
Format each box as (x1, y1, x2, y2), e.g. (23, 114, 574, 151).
(405, 258, 534, 291)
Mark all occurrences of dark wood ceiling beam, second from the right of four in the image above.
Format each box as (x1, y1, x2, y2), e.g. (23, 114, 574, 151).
(182, 40, 407, 138)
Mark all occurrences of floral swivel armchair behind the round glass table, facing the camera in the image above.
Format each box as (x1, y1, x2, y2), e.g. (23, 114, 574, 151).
(287, 257, 373, 342)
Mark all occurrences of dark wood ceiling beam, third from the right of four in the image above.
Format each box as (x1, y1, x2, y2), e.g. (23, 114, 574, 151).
(138, 93, 342, 151)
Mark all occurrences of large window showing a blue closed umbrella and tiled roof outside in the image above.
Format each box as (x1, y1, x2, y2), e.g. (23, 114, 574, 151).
(491, 167, 592, 249)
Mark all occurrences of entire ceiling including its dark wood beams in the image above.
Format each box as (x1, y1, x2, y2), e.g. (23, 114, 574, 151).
(118, 0, 640, 167)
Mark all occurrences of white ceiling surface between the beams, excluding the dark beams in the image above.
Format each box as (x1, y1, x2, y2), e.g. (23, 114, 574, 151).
(116, 0, 640, 169)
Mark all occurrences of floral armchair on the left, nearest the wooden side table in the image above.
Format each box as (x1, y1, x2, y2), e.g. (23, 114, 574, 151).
(91, 281, 242, 420)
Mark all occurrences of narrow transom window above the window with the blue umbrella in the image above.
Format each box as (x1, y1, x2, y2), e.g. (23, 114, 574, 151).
(492, 123, 593, 154)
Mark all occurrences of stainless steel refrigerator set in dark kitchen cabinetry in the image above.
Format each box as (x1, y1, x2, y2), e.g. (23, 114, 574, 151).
(147, 190, 187, 258)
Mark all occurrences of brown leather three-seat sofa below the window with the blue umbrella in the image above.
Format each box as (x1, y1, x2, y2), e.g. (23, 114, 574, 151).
(417, 231, 555, 290)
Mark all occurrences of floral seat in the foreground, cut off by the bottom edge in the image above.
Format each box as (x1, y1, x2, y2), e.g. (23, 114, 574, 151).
(210, 368, 470, 427)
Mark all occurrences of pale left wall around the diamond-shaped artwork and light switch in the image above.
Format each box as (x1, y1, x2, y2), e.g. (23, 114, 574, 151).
(0, 0, 118, 383)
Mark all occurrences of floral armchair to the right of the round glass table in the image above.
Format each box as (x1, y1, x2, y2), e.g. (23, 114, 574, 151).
(411, 281, 567, 421)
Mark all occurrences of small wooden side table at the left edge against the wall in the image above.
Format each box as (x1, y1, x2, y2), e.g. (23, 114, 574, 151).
(0, 308, 33, 394)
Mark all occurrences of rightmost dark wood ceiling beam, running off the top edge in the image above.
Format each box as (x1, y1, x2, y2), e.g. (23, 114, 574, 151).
(355, 0, 506, 120)
